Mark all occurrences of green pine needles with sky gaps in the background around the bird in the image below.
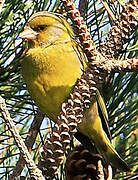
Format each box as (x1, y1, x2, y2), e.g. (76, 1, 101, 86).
(0, 0, 138, 179)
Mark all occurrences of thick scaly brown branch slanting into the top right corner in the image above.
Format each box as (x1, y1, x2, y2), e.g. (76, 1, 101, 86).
(99, 0, 138, 58)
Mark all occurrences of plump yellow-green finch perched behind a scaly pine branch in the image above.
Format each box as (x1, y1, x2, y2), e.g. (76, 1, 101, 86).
(19, 11, 129, 171)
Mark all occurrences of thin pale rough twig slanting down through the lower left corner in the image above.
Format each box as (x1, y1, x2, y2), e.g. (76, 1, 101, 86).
(0, 96, 44, 180)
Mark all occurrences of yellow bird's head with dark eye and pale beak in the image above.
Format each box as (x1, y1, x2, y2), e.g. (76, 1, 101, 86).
(19, 11, 73, 47)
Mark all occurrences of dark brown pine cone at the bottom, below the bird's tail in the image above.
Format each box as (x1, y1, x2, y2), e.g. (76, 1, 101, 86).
(65, 145, 109, 180)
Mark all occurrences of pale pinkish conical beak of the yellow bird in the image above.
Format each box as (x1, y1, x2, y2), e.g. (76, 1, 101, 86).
(19, 27, 38, 40)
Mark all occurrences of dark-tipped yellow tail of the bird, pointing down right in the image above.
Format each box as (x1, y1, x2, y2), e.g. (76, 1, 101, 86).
(97, 132, 129, 171)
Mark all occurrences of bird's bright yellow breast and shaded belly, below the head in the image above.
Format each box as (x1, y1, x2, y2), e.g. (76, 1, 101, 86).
(22, 42, 82, 121)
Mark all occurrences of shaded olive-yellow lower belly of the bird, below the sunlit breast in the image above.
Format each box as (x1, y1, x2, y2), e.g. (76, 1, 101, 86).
(28, 77, 72, 121)
